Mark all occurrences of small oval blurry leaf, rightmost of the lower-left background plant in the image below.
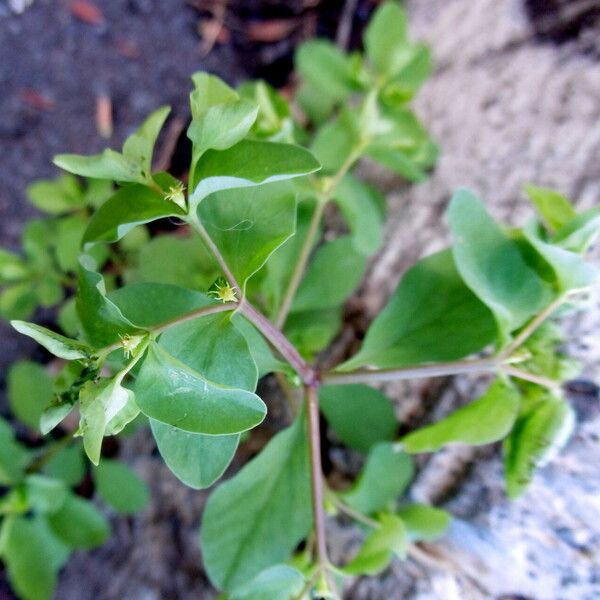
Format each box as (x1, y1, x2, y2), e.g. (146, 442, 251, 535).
(93, 460, 150, 515)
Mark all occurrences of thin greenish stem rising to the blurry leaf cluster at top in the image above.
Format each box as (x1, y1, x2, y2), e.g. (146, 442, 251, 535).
(275, 144, 363, 329)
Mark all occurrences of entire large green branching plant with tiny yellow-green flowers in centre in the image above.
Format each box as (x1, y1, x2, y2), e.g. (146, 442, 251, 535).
(4, 2, 600, 600)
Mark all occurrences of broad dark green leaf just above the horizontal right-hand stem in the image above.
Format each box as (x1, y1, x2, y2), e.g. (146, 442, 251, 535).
(340, 251, 496, 371)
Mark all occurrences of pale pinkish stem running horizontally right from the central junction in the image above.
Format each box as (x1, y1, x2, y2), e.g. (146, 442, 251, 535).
(322, 358, 501, 384)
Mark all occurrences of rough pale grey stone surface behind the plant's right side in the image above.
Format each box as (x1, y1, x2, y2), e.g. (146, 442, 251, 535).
(347, 0, 600, 600)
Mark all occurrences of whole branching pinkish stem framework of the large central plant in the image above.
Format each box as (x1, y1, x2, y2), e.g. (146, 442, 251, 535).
(180, 180, 565, 593)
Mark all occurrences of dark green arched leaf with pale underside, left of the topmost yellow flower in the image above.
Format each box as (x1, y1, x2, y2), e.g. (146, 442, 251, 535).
(83, 184, 185, 250)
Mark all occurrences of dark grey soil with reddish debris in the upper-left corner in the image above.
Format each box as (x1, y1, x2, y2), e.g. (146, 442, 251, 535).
(0, 0, 373, 382)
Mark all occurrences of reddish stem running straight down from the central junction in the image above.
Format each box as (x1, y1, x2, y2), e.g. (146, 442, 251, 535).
(304, 385, 329, 573)
